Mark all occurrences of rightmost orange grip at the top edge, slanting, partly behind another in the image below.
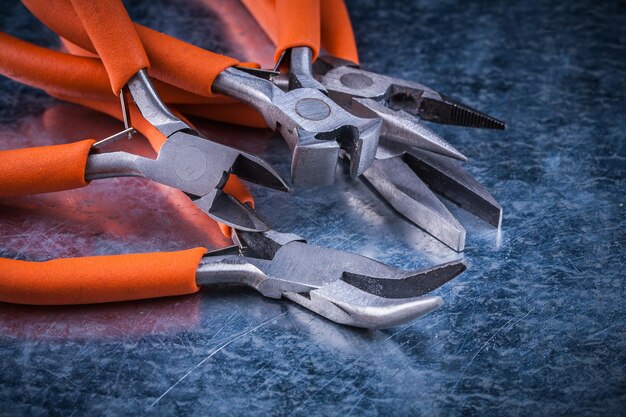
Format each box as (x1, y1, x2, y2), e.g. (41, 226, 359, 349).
(320, 0, 359, 64)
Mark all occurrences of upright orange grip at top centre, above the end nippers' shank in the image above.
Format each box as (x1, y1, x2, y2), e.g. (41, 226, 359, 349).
(274, 0, 320, 62)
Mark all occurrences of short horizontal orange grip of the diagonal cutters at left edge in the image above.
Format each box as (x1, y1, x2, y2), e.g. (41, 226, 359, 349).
(0, 139, 95, 197)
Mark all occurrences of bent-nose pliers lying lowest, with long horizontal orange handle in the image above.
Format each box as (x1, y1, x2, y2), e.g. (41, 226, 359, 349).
(0, 224, 465, 329)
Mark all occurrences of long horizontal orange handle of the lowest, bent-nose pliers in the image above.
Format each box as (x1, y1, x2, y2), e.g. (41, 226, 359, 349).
(0, 248, 206, 305)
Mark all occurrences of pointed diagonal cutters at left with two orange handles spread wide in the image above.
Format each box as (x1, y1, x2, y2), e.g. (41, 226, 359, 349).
(7, 2, 288, 231)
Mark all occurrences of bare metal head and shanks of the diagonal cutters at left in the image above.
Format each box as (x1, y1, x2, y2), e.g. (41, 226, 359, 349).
(86, 70, 288, 231)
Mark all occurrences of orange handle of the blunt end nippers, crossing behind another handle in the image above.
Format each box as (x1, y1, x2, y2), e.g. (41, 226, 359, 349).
(22, 0, 239, 96)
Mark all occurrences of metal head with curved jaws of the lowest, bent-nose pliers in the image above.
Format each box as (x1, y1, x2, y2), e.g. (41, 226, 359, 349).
(196, 231, 465, 329)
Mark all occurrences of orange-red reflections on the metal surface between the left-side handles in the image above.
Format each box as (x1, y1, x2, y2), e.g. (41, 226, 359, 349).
(0, 104, 228, 260)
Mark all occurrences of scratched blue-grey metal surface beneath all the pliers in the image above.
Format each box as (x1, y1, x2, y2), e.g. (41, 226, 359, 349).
(0, 0, 626, 416)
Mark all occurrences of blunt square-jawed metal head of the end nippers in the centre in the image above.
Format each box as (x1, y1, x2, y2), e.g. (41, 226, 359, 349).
(213, 68, 381, 186)
